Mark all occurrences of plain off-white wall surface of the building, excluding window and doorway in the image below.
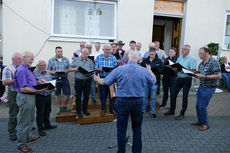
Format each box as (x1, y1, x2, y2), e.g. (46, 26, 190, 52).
(3, 0, 230, 64)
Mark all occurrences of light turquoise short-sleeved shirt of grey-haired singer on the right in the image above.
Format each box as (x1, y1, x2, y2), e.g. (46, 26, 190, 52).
(176, 55, 197, 78)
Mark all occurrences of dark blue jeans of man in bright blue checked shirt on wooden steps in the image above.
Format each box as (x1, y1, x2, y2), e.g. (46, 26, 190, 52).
(99, 85, 114, 111)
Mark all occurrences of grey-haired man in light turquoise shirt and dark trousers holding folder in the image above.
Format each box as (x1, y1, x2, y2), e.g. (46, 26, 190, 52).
(165, 45, 196, 120)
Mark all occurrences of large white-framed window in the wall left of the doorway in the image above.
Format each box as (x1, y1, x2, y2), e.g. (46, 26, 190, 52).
(51, 0, 116, 39)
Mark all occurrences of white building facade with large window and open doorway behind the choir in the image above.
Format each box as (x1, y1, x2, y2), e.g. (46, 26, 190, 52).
(0, 0, 230, 65)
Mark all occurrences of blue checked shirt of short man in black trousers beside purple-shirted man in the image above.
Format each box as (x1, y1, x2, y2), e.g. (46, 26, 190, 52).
(34, 69, 52, 96)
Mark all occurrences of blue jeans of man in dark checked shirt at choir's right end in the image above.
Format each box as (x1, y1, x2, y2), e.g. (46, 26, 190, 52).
(196, 86, 216, 126)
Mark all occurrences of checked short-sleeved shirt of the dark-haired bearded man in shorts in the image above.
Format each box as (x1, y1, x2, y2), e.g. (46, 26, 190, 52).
(47, 56, 70, 77)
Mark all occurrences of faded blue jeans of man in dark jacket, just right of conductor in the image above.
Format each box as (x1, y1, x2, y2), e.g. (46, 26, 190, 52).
(142, 84, 157, 114)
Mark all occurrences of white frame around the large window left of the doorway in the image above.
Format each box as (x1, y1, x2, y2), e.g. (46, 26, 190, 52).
(50, 0, 117, 41)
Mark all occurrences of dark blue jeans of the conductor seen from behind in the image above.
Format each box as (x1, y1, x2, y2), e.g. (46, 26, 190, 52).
(117, 98, 143, 153)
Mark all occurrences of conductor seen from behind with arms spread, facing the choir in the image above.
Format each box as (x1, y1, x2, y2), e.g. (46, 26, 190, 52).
(94, 51, 156, 153)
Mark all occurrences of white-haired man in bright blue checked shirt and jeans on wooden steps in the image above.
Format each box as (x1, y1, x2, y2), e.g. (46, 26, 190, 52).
(95, 45, 117, 116)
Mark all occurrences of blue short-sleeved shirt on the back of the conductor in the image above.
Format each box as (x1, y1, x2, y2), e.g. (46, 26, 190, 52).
(104, 62, 155, 97)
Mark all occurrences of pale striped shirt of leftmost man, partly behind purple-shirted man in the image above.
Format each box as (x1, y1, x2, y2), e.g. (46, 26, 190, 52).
(2, 64, 17, 91)
